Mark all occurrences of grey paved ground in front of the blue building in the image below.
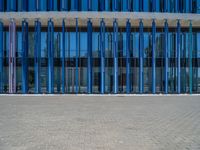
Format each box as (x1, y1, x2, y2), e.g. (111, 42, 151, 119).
(0, 96, 200, 150)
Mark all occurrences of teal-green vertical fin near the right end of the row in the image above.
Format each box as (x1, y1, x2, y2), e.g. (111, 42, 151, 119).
(188, 21, 193, 94)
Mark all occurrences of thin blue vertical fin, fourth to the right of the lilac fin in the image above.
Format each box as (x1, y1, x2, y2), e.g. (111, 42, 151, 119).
(61, 19, 65, 94)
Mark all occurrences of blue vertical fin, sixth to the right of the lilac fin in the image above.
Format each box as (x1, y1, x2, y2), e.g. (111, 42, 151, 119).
(87, 20, 92, 94)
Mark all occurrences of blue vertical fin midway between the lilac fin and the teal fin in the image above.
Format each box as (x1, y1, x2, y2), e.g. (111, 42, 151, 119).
(100, 19, 105, 94)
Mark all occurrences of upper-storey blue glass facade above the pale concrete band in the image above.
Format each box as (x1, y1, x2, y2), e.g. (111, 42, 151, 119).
(0, 0, 200, 13)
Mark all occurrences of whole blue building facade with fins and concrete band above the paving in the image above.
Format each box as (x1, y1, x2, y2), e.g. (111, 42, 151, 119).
(0, 0, 200, 94)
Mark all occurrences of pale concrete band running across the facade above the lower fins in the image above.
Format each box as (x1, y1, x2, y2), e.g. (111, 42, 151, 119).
(0, 11, 200, 28)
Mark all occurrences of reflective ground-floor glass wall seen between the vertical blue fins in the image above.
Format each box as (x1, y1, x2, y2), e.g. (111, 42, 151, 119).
(0, 21, 200, 94)
